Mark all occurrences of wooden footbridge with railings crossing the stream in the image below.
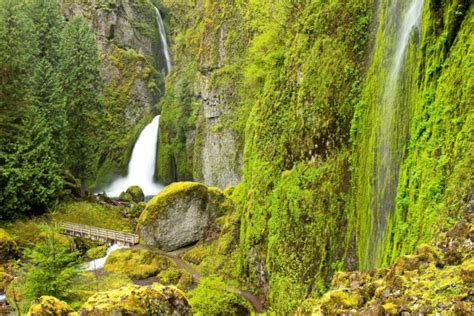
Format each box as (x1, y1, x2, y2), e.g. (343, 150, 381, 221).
(61, 222, 138, 247)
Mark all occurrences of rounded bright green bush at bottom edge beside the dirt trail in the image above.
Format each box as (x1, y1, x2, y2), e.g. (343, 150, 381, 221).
(189, 276, 251, 315)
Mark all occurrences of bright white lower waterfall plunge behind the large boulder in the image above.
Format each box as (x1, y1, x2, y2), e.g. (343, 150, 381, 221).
(105, 115, 163, 197)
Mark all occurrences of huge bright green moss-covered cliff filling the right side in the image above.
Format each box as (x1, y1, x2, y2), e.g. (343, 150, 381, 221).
(150, 0, 474, 312)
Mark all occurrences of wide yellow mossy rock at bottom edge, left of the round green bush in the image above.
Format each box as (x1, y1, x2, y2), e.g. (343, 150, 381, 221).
(81, 283, 191, 315)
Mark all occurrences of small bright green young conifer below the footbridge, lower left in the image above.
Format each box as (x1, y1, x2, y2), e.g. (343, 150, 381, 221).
(13, 227, 79, 308)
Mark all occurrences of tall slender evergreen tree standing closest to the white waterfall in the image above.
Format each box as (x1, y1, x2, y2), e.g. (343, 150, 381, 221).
(59, 17, 102, 188)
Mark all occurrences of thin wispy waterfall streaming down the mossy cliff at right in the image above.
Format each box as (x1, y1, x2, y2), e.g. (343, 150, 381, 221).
(366, 0, 423, 267)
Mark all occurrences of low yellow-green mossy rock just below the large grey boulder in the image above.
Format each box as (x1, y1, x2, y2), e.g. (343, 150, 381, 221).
(104, 248, 176, 279)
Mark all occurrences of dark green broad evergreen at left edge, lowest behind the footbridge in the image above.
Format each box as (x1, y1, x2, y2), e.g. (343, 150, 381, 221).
(0, 107, 63, 219)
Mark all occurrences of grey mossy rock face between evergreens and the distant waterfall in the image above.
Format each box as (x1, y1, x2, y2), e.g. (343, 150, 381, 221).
(63, 0, 164, 185)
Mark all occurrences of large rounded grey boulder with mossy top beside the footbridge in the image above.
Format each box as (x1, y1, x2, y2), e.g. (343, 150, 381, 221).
(138, 182, 232, 251)
